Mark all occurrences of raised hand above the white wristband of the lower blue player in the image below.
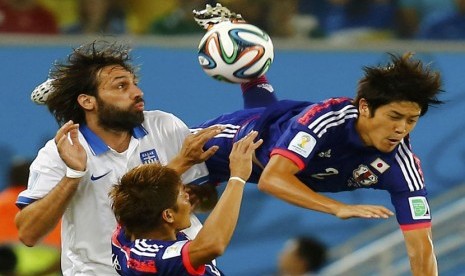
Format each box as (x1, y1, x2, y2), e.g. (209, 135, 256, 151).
(229, 131, 263, 180)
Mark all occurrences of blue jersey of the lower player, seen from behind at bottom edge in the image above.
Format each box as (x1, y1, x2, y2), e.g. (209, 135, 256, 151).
(111, 226, 224, 276)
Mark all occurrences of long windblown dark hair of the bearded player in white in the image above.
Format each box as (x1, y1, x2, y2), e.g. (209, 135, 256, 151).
(47, 40, 138, 125)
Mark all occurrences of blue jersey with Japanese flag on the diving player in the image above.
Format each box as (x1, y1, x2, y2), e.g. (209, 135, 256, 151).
(190, 98, 431, 229)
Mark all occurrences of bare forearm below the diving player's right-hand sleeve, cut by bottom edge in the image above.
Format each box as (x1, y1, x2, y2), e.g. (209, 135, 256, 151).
(403, 227, 438, 276)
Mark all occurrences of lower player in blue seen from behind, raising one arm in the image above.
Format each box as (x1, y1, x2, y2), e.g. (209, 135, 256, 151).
(110, 132, 263, 276)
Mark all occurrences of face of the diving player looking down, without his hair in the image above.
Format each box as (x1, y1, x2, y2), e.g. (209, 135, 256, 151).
(357, 101, 421, 152)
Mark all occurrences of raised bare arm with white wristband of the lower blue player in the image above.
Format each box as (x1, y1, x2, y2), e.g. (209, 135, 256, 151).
(188, 131, 263, 268)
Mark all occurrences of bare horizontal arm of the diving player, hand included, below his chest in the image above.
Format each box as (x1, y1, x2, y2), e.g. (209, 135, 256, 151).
(258, 155, 394, 219)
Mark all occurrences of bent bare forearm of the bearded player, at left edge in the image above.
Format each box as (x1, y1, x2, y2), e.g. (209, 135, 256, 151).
(15, 177, 80, 246)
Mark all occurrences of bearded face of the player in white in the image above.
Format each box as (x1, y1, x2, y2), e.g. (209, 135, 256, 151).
(96, 66, 144, 131)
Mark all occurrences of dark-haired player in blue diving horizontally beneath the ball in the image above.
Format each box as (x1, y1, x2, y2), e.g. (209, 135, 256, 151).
(192, 54, 442, 275)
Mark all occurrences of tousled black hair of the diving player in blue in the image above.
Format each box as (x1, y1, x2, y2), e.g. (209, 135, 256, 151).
(355, 52, 443, 116)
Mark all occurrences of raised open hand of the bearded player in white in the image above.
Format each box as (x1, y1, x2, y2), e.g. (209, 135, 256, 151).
(55, 121, 87, 171)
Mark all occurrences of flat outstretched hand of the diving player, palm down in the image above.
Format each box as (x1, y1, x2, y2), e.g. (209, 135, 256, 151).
(335, 204, 394, 219)
